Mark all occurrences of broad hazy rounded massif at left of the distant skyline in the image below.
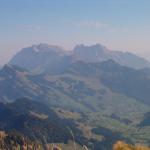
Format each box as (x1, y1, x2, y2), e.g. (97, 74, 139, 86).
(10, 44, 72, 73)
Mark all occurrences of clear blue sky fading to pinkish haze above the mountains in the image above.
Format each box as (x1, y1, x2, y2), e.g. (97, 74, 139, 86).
(0, 0, 150, 64)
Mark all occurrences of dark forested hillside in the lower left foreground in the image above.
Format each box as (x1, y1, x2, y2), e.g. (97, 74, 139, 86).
(0, 98, 133, 150)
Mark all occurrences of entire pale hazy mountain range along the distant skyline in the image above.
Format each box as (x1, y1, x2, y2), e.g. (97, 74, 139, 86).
(9, 44, 150, 73)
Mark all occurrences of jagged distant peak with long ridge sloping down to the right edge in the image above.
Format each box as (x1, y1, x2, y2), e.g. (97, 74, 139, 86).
(73, 44, 150, 68)
